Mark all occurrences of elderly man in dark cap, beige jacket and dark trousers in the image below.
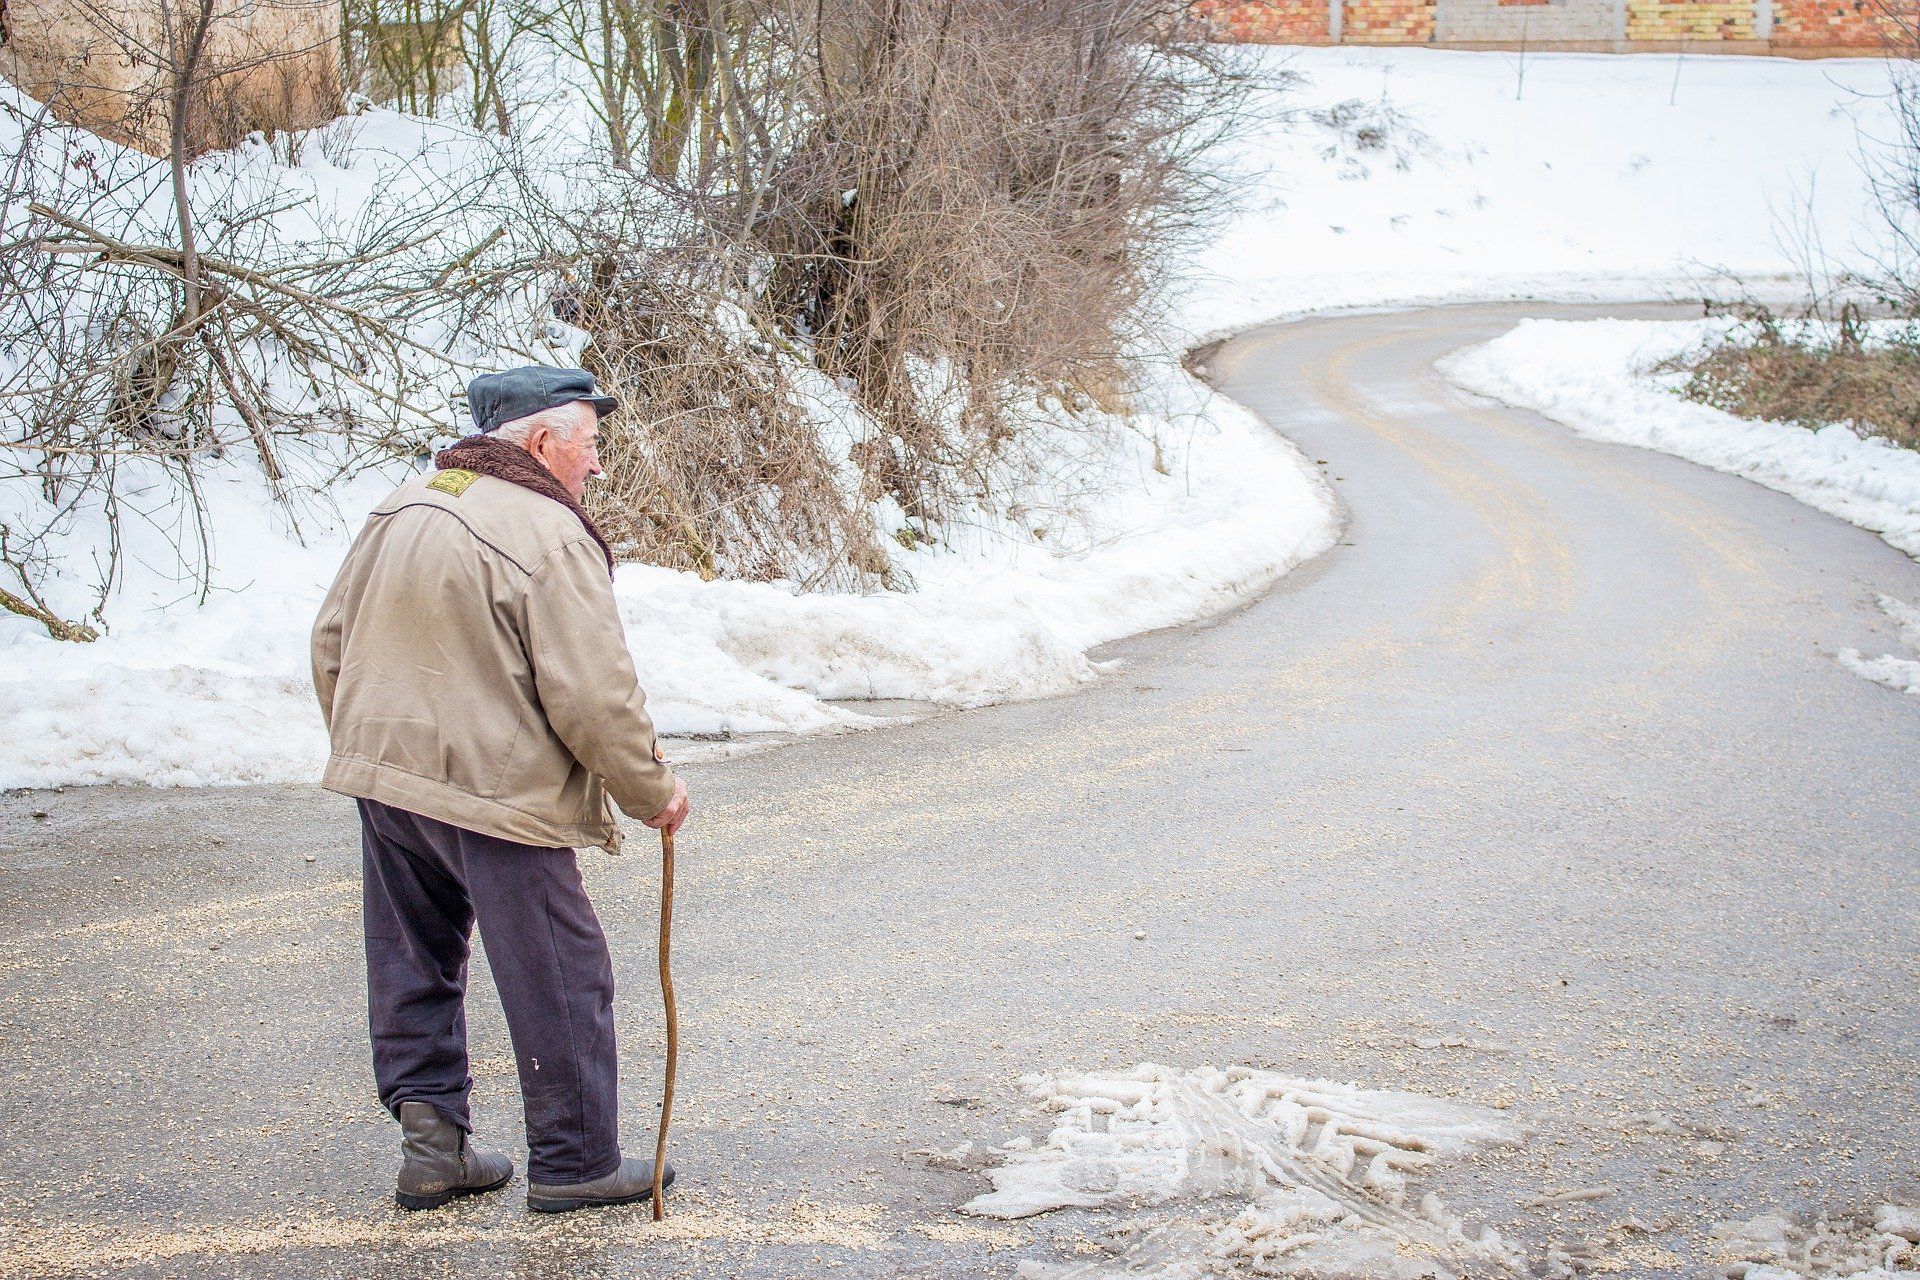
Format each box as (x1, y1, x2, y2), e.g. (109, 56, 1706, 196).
(313, 368, 687, 1213)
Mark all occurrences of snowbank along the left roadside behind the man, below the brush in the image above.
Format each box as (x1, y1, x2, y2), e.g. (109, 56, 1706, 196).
(0, 353, 1332, 787)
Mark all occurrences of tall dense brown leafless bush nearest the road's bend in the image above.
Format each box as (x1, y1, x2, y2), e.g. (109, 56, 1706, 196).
(751, 0, 1274, 522)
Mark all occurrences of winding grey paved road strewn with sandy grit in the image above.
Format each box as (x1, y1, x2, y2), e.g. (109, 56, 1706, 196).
(0, 307, 1920, 1280)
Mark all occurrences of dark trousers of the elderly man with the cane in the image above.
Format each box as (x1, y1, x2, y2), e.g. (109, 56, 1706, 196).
(359, 800, 620, 1184)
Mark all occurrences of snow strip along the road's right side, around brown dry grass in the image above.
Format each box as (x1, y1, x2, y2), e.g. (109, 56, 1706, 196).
(1440, 320, 1920, 558)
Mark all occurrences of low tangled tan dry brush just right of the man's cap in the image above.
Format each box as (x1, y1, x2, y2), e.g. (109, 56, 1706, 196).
(522, 172, 891, 587)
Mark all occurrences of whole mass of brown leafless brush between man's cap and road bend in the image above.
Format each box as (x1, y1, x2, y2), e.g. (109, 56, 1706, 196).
(499, 0, 1274, 583)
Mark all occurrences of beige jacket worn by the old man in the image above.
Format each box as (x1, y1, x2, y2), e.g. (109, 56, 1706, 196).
(313, 470, 674, 852)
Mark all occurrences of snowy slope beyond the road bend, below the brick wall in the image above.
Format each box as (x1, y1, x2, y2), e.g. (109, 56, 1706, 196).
(1181, 48, 1893, 338)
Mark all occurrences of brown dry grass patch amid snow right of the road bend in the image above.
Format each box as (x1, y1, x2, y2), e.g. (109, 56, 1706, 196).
(1659, 307, 1920, 449)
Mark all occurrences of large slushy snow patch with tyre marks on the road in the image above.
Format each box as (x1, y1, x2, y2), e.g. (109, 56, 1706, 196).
(962, 1063, 1519, 1280)
